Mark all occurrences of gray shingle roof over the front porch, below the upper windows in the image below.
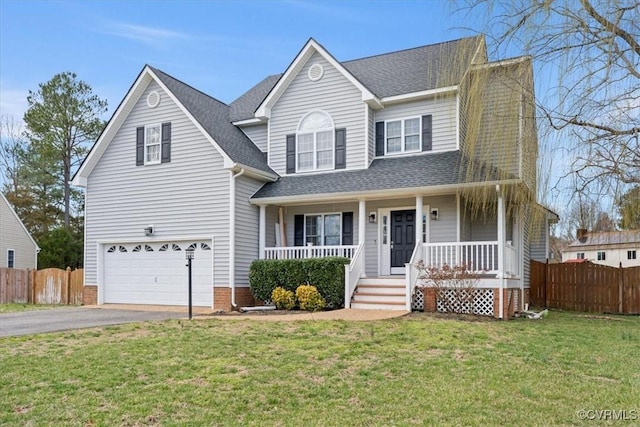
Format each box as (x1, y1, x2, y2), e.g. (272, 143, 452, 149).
(251, 151, 517, 204)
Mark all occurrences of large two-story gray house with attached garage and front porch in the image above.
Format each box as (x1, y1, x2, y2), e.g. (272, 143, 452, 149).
(73, 37, 553, 317)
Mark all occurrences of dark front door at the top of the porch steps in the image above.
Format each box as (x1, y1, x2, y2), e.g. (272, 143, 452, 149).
(391, 210, 416, 274)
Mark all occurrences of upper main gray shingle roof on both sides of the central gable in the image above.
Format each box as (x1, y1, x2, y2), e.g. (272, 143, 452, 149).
(231, 36, 482, 122)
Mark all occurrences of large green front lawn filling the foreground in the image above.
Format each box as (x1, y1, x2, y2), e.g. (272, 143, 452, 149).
(0, 312, 640, 426)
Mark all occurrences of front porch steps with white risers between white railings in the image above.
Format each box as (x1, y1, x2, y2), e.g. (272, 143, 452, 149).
(351, 277, 406, 310)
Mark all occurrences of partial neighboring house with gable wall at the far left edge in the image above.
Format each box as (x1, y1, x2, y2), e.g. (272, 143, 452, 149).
(0, 193, 40, 269)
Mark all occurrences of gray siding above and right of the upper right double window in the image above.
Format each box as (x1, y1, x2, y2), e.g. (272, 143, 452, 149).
(375, 95, 457, 151)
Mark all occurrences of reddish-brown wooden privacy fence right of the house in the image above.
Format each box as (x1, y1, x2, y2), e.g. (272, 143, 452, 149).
(529, 261, 640, 314)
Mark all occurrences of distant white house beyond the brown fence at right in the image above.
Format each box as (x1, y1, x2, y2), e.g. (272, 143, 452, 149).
(562, 229, 640, 267)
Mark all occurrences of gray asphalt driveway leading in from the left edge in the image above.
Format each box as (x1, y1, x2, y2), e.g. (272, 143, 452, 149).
(0, 307, 187, 337)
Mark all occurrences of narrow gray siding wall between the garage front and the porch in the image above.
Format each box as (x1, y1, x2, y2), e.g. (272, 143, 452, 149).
(235, 176, 263, 286)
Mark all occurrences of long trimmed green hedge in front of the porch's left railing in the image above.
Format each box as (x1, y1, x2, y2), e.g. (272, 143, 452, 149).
(249, 257, 349, 308)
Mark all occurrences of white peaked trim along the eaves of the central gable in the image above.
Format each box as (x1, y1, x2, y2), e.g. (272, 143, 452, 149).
(255, 39, 382, 119)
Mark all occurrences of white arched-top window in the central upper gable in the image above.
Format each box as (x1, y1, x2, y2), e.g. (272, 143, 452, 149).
(296, 111, 335, 172)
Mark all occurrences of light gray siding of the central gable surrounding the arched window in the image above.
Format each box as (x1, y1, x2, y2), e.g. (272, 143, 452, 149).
(269, 54, 367, 175)
